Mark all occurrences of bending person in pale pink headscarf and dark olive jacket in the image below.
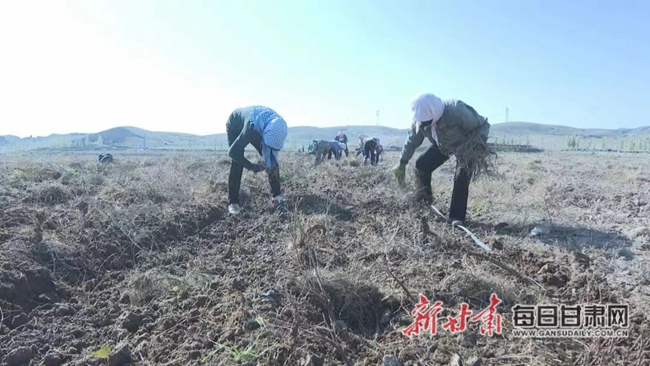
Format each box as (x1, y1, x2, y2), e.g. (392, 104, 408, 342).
(393, 94, 494, 222)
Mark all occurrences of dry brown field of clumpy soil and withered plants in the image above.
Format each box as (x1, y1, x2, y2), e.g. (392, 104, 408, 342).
(0, 153, 650, 366)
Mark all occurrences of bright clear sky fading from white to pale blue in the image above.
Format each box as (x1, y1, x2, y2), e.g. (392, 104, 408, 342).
(0, 0, 650, 137)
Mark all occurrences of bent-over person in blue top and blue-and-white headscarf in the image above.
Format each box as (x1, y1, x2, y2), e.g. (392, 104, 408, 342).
(226, 106, 287, 215)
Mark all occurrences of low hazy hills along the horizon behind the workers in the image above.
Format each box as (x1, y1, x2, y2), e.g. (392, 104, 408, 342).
(0, 122, 650, 152)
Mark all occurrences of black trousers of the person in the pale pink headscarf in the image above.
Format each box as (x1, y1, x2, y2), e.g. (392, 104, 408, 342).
(415, 144, 472, 221)
